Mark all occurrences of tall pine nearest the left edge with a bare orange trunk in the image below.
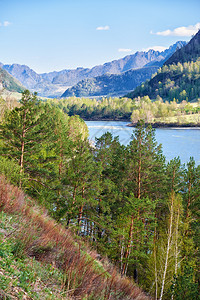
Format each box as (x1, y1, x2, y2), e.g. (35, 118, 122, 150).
(0, 90, 54, 191)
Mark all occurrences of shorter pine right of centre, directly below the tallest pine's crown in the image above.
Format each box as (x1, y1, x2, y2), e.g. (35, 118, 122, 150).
(121, 193, 156, 282)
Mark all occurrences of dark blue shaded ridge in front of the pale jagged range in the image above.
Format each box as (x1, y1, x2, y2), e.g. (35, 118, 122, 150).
(61, 67, 157, 97)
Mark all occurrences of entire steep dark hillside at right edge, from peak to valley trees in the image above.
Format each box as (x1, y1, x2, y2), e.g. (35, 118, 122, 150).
(127, 31, 200, 101)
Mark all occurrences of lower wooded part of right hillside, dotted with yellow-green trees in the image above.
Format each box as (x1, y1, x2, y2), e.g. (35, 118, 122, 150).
(127, 60, 200, 102)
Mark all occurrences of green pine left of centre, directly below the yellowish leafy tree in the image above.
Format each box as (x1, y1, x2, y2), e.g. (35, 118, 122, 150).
(61, 140, 99, 235)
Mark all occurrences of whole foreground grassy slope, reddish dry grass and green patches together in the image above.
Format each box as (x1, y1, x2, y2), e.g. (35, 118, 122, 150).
(0, 177, 148, 300)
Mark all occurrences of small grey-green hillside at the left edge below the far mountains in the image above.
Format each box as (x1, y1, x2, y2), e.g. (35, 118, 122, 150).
(0, 68, 24, 93)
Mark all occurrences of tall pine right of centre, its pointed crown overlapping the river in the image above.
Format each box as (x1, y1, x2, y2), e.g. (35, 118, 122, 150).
(123, 121, 165, 280)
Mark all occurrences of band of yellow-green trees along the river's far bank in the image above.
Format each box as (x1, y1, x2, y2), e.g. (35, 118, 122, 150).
(48, 96, 200, 124)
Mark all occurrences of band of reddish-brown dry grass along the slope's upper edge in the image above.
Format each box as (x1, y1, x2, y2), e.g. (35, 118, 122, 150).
(0, 177, 149, 300)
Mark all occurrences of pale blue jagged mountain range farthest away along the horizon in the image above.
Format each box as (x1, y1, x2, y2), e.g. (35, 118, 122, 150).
(2, 42, 186, 97)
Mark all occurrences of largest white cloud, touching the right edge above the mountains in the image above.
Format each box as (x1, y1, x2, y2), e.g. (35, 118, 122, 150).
(150, 22, 200, 37)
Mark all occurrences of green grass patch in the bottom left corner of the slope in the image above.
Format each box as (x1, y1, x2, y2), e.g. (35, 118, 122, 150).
(0, 212, 66, 299)
